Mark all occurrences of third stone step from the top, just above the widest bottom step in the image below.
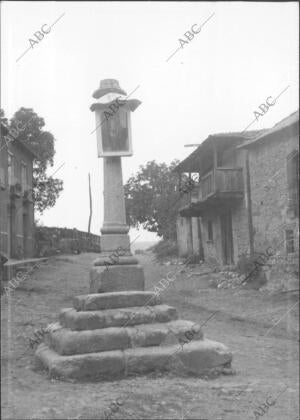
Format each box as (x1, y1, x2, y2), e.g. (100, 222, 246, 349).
(46, 320, 203, 355)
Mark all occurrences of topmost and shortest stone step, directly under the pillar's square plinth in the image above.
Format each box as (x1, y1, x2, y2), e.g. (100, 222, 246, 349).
(73, 291, 161, 311)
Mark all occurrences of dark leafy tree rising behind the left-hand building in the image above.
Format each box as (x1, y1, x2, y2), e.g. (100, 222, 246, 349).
(1, 107, 63, 213)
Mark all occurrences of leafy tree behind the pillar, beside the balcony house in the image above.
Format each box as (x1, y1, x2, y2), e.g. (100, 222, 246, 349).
(124, 160, 180, 240)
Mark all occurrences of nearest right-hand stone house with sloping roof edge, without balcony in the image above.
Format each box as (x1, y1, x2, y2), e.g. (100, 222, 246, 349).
(240, 112, 299, 254)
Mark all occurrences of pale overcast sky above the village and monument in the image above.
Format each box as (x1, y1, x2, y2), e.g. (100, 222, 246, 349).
(1, 1, 299, 240)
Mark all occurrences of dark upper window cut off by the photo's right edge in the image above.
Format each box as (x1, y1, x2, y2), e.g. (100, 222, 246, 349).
(287, 150, 299, 216)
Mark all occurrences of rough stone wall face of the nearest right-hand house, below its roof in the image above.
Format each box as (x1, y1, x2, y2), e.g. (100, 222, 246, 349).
(249, 132, 299, 252)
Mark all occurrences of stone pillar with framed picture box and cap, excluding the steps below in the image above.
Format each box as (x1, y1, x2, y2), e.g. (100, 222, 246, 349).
(90, 79, 144, 293)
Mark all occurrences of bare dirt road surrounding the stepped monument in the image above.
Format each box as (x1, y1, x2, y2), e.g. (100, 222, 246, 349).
(1, 254, 299, 420)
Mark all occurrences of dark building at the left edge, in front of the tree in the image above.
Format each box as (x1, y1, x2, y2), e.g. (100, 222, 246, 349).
(0, 124, 37, 258)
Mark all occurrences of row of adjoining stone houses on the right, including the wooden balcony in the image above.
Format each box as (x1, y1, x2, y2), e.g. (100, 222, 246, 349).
(174, 108, 299, 265)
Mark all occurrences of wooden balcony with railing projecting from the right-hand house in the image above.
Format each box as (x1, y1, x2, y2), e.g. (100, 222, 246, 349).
(180, 168, 244, 216)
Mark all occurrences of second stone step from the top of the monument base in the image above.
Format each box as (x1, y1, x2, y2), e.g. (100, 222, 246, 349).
(59, 305, 178, 331)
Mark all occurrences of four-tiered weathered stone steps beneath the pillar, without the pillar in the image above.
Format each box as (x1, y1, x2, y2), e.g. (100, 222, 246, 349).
(35, 291, 232, 380)
